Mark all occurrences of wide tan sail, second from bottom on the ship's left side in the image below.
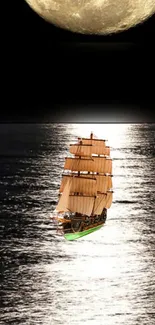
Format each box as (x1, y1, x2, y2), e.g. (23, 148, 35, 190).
(59, 175, 97, 195)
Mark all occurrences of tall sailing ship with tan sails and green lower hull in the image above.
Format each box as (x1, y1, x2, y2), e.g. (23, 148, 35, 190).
(53, 132, 113, 240)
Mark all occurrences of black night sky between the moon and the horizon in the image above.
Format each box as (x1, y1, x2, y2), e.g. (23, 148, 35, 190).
(0, 0, 155, 122)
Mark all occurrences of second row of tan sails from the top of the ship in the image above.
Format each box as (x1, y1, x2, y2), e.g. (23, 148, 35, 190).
(70, 144, 110, 157)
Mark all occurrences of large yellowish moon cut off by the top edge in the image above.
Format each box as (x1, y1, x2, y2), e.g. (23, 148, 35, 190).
(26, 0, 155, 35)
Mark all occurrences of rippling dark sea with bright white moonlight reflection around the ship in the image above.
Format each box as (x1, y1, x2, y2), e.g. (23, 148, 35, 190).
(0, 124, 155, 325)
